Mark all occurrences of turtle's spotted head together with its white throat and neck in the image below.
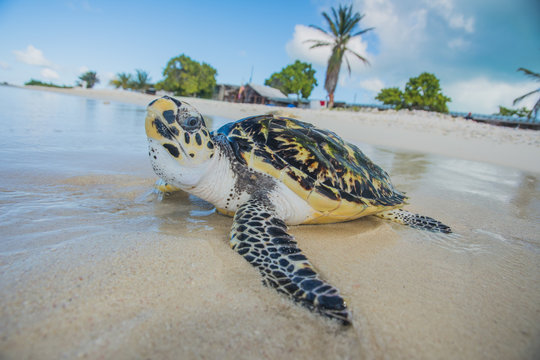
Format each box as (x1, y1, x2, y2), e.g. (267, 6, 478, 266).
(145, 97, 234, 207)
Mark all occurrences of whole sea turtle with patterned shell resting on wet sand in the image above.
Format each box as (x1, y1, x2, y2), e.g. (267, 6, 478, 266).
(145, 96, 451, 324)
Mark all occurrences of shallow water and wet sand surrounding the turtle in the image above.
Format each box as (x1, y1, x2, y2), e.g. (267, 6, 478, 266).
(0, 87, 540, 358)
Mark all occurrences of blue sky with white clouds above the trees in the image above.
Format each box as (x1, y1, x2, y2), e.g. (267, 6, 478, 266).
(0, 0, 540, 113)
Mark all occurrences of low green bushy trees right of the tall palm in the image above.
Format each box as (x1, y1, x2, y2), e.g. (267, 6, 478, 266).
(375, 73, 452, 113)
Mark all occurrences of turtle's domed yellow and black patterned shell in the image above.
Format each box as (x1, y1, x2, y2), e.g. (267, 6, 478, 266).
(217, 115, 406, 223)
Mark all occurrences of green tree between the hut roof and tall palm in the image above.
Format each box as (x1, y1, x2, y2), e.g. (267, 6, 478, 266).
(264, 60, 317, 99)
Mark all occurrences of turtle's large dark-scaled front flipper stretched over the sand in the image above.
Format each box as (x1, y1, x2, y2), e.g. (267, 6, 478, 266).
(231, 195, 351, 325)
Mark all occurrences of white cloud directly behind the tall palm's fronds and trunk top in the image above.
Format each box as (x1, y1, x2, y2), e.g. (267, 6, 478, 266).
(285, 25, 371, 72)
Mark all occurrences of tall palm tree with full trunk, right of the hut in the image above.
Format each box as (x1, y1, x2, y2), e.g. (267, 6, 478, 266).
(307, 5, 373, 108)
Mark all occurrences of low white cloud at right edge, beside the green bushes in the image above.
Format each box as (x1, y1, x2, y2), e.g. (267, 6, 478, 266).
(443, 77, 538, 114)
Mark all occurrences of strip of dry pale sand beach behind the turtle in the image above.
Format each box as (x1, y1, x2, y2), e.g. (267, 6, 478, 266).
(22, 86, 540, 173)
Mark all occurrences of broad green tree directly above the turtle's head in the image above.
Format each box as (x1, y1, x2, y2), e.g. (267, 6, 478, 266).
(156, 54, 217, 98)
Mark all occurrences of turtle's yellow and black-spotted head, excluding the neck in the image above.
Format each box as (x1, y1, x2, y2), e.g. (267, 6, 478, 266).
(145, 96, 215, 187)
